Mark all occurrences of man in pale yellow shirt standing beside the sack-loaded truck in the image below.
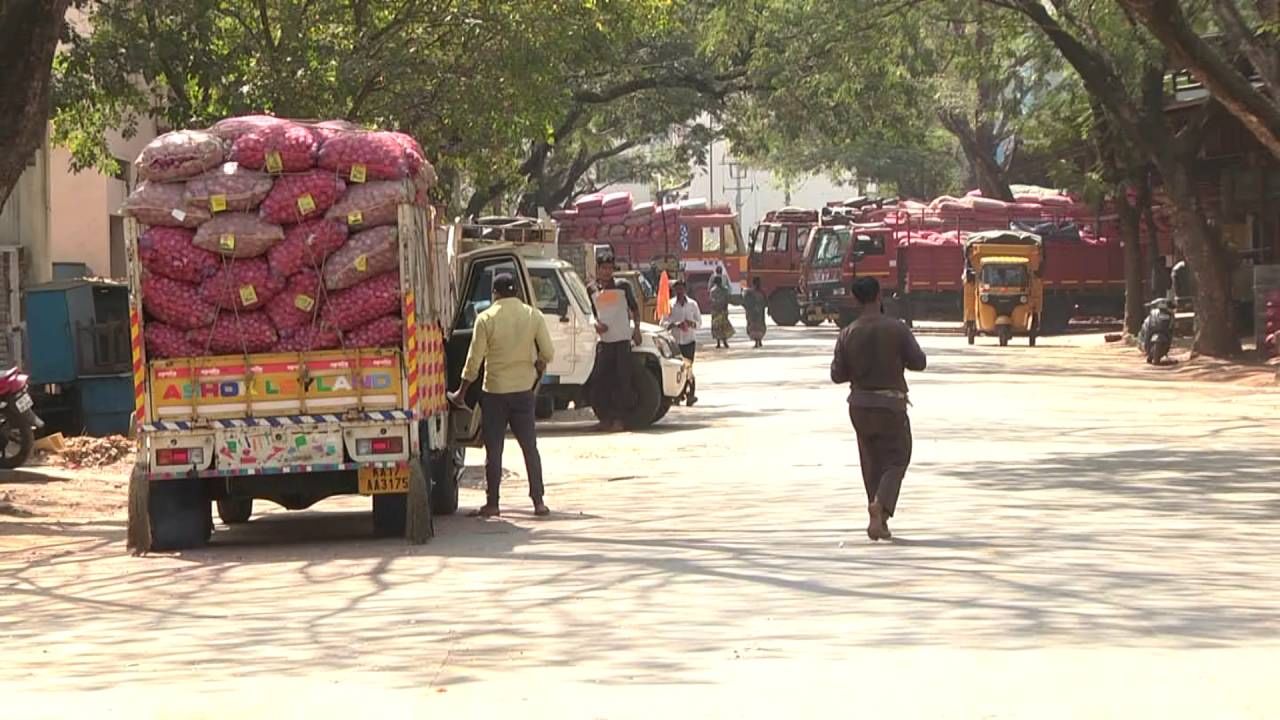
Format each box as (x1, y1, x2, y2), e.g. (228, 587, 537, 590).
(449, 274, 556, 518)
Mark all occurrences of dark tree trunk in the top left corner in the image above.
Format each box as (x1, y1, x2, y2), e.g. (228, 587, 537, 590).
(0, 0, 70, 208)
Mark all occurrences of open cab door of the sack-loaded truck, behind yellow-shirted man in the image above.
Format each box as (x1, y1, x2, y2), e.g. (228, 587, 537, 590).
(445, 246, 531, 446)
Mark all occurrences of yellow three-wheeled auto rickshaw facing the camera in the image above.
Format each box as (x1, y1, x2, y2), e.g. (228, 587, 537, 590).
(964, 231, 1044, 347)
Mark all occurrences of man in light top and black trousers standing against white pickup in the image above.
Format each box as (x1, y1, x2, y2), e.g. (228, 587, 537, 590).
(591, 256, 640, 432)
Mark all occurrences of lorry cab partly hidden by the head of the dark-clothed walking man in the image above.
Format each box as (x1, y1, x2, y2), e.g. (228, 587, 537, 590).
(803, 224, 892, 328)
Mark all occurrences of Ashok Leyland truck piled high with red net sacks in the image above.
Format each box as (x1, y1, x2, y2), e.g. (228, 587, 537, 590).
(123, 117, 499, 552)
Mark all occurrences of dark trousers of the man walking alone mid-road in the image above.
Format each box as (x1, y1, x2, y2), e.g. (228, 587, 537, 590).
(849, 406, 911, 518)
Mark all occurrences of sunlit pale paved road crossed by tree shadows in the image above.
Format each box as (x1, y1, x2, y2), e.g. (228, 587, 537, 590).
(0, 327, 1280, 719)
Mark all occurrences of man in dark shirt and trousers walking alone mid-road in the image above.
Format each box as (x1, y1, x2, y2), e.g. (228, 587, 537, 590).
(831, 278, 925, 541)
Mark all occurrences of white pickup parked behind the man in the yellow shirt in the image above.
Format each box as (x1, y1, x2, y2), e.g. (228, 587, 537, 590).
(454, 218, 689, 429)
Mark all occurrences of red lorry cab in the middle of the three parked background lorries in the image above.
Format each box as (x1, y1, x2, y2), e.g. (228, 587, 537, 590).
(748, 208, 818, 327)
